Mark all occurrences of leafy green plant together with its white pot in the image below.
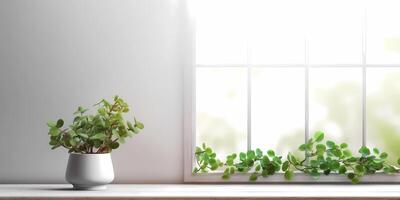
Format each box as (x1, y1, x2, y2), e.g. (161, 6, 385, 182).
(47, 96, 144, 189)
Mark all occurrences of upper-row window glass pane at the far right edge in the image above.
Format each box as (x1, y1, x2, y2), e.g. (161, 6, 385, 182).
(367, 0, 400, 64)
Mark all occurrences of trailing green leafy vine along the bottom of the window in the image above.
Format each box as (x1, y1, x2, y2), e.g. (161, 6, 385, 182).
(193, 131, 400, 183)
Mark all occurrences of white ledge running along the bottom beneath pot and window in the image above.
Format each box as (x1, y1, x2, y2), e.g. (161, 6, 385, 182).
(0, 184, 400, 200)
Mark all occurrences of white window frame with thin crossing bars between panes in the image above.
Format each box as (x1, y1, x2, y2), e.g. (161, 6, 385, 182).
(182, 2, 400, 183)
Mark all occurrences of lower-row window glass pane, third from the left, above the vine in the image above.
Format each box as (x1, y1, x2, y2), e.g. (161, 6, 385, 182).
(309, 68, 362, 152)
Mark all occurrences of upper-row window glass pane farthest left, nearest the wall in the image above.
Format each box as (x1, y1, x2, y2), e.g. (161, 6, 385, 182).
(193, 0, 246, 64)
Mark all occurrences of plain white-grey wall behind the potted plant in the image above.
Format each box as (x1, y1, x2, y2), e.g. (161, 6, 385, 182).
(0, 0, 189, 183)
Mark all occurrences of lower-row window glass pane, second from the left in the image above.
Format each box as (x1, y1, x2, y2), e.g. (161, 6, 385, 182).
(251, 68, 305, 155)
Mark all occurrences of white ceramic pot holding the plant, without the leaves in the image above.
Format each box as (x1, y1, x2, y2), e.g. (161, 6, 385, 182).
(65, 153, 114, 190)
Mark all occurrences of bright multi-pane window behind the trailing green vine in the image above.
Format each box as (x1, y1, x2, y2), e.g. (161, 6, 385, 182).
(185, 0, 400, 182)
